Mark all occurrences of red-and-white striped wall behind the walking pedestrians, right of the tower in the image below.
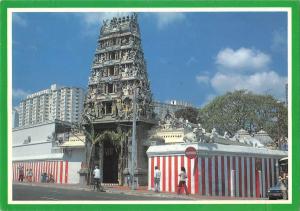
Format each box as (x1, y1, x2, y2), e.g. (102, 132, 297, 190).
(148, 153, 279, 198)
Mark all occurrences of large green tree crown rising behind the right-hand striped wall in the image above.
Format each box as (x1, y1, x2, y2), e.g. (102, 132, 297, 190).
(198, 90, 288, 140)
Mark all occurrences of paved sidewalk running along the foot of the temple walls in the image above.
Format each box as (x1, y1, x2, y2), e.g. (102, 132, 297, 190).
(13, 182, 262, 200)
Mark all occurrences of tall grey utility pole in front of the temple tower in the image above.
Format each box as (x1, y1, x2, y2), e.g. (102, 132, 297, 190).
(131, 88, 137, 190)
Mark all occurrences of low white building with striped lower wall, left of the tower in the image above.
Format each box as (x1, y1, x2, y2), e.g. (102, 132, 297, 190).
(12, 120, 85, 183)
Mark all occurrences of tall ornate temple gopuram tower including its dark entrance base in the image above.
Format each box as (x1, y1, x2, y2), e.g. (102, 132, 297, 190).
(85, 14, 154, 184)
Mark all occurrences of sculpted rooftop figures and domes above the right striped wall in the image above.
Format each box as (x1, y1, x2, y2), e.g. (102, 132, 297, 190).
(148, 115, 278, 149)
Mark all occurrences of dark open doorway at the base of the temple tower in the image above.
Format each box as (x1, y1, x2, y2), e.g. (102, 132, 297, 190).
(103, 140, 119, 183)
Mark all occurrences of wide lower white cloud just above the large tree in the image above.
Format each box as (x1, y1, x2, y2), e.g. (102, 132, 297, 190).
(211, 71, 287, 99)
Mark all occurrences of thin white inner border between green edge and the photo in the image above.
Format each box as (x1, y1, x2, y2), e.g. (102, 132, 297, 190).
(7, 7, 292, 204)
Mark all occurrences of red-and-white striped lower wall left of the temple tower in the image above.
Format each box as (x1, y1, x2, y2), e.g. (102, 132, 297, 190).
(12, 160, 69, 184)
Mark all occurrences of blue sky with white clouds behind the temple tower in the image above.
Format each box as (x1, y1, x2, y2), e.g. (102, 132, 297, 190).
(12, 12, 287, 106)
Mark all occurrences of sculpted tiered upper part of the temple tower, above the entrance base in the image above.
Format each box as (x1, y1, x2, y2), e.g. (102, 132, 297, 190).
(85, 14, 153, 122)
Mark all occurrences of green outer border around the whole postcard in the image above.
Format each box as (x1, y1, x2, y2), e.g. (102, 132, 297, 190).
(0, 0, 300, 211)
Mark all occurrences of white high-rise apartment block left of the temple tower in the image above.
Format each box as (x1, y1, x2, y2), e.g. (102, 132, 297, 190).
(19, 84, 84, 127)
